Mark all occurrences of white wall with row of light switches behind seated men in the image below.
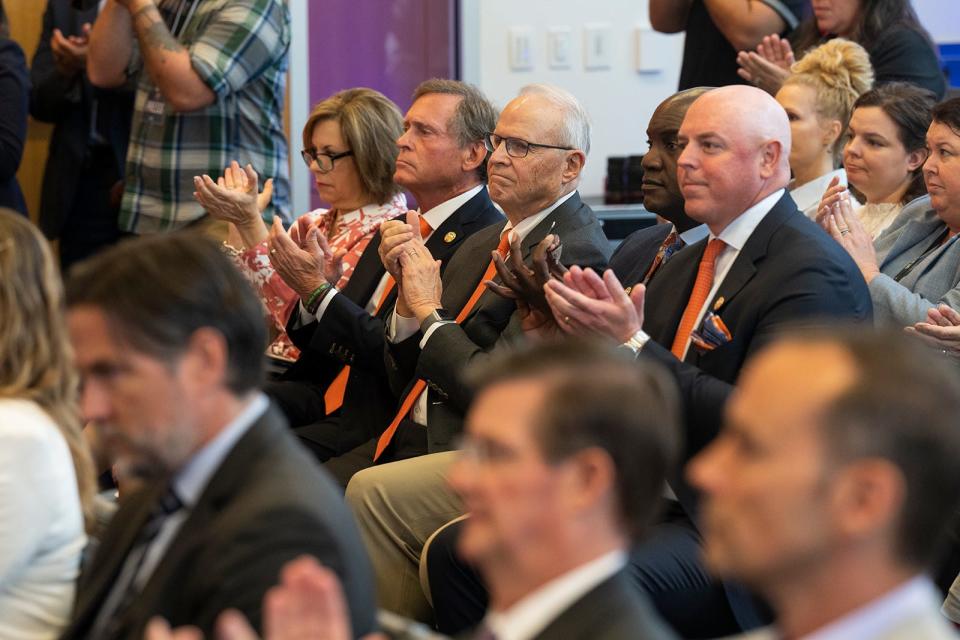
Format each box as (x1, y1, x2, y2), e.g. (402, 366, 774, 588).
(461, 0, 680, 196)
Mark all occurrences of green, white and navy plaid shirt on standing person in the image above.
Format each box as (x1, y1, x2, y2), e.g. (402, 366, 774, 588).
(119, 0, 290, 233)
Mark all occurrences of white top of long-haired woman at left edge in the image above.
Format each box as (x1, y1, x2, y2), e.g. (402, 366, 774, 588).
(0, 398, 87, 640)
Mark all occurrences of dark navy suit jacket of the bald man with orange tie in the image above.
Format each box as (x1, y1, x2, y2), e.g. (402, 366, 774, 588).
(643, 193, 872, 504)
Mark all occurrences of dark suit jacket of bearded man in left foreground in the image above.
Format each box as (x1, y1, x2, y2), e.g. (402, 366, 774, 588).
(62, 408, 374, 640)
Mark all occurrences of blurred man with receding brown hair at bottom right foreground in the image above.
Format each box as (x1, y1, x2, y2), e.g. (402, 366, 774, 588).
(687, 330, 960, 640)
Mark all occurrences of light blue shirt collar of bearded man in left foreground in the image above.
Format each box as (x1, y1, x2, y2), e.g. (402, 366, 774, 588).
(173, 392, 270, 508)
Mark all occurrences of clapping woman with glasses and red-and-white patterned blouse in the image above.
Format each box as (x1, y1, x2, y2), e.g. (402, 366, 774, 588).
(195, 88, 407, 360)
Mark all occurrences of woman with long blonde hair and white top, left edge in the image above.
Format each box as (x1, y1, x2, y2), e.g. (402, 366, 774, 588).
(0, 209, 96, 639)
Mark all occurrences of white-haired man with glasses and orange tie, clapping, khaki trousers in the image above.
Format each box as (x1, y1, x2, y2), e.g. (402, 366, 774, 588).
(327, 85, 609, 618)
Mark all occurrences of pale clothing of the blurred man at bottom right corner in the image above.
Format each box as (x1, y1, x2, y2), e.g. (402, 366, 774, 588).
(738, 576, 956, 640)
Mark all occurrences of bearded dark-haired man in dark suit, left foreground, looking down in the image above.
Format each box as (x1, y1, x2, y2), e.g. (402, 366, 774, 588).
(63, 234, 374, 640)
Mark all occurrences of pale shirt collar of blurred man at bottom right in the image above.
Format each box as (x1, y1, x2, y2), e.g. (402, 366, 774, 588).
(803, 576, 946, 640)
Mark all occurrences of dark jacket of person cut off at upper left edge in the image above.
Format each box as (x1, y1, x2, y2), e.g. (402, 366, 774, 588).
(0, 36, 30, 214)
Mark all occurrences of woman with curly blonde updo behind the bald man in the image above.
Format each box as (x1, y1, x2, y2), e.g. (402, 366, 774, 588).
(776, 38, 873, 218)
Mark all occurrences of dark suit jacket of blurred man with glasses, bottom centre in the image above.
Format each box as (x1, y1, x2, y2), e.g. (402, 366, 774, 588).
(461, 571, 677, 640)
